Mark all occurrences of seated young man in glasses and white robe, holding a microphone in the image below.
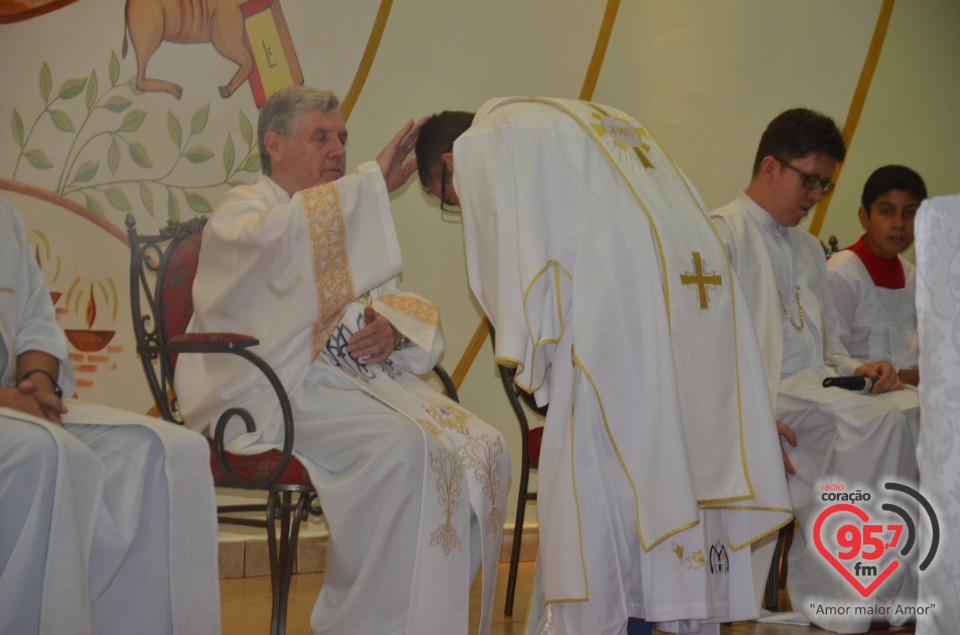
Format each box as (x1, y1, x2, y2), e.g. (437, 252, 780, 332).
(712, 108, 919, 633)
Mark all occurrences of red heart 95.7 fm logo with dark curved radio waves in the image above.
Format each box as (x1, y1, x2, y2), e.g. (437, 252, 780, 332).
(813, 483, 940, 598)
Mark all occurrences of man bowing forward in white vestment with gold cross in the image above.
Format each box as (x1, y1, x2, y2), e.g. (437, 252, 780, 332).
(417, 99, 790, 635)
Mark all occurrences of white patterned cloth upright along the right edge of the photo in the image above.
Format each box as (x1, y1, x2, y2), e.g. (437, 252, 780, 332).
(916, 195, 960, 635)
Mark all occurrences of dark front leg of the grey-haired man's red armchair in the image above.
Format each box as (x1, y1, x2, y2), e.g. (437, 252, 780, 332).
(267, 491, 309, 635)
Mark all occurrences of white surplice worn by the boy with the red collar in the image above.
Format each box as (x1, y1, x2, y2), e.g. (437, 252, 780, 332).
(827, 249, 920, 370)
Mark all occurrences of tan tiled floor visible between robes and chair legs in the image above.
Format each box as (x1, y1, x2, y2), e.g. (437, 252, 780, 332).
(220, 562, 916, 635)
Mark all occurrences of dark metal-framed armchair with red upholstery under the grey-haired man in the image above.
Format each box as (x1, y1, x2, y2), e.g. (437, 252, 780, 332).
(126, 214, 458, 635)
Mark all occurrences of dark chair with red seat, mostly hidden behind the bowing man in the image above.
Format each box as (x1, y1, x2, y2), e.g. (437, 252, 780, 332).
(487, 320, 547, 615)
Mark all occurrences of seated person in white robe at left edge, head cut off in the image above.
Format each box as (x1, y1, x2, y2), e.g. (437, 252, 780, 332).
(0, 199, 220, 635)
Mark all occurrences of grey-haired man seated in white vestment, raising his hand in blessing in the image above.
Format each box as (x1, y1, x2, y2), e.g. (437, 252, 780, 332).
(176, 86, 510, 635)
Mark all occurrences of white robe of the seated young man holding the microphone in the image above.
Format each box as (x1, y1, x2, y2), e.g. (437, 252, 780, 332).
(712, 194, 919, 633)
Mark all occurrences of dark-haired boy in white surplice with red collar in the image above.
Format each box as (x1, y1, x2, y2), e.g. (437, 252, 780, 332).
(827, 165, 927, 386)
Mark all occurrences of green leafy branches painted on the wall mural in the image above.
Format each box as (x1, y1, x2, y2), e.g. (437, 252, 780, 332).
(11, 53, 260, 221)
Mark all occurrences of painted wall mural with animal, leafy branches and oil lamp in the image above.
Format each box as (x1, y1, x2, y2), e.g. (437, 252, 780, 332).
(0, 0, 389, 411)
